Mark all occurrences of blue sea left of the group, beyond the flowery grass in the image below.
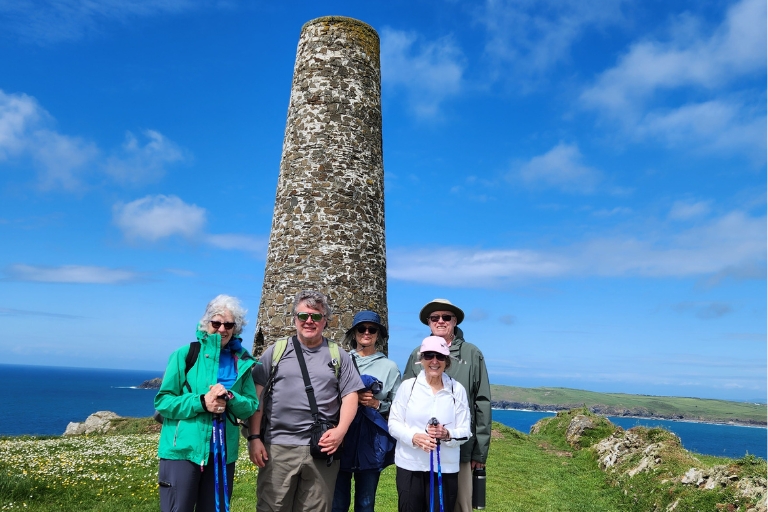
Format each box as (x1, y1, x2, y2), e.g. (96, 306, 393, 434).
(0, 364, 162, 436)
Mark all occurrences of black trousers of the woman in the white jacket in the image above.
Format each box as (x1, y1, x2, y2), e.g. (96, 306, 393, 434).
(395, 468, 459, 512)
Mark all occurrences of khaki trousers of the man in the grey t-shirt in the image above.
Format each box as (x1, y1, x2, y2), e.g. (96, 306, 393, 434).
(256, 444, 339, 512)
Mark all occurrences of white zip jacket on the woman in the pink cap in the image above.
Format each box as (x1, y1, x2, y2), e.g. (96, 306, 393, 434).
(389, 371, 472, 473)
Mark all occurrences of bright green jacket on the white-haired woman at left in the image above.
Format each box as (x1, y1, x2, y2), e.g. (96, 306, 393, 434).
(155, 331, 259, 466)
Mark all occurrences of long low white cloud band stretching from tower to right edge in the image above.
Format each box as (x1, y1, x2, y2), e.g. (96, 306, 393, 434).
(387, 211, 766, 287)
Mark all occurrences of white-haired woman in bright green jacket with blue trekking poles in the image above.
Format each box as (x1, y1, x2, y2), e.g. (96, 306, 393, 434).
(155, 295, 259, 512)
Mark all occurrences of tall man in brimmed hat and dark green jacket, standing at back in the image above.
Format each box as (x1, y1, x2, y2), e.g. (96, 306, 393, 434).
(403, 299, 491, 512)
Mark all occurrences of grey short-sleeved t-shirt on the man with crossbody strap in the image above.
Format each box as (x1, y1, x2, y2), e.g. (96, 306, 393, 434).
(253, 338, 363, 445)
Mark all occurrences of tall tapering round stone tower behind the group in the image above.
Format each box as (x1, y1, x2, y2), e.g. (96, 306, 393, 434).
(253, 16, 387, 354)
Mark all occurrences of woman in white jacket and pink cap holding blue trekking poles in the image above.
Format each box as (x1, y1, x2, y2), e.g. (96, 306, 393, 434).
(389, 336, 472, 512)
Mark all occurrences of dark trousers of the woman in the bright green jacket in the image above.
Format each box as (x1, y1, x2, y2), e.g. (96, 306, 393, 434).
(158, 457, 235, 512)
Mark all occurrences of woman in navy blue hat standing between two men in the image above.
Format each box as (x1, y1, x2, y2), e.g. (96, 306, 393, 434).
(333, 311, 400, 512)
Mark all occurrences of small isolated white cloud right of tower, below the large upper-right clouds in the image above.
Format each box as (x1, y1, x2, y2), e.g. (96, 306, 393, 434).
(509, 142, 601, 193)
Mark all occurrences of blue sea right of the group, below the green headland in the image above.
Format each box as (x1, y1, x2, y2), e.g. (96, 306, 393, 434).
(493, 409, 768, 459)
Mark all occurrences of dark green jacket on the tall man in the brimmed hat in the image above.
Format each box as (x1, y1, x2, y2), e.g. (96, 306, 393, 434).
(403, 327, 491, 464)
